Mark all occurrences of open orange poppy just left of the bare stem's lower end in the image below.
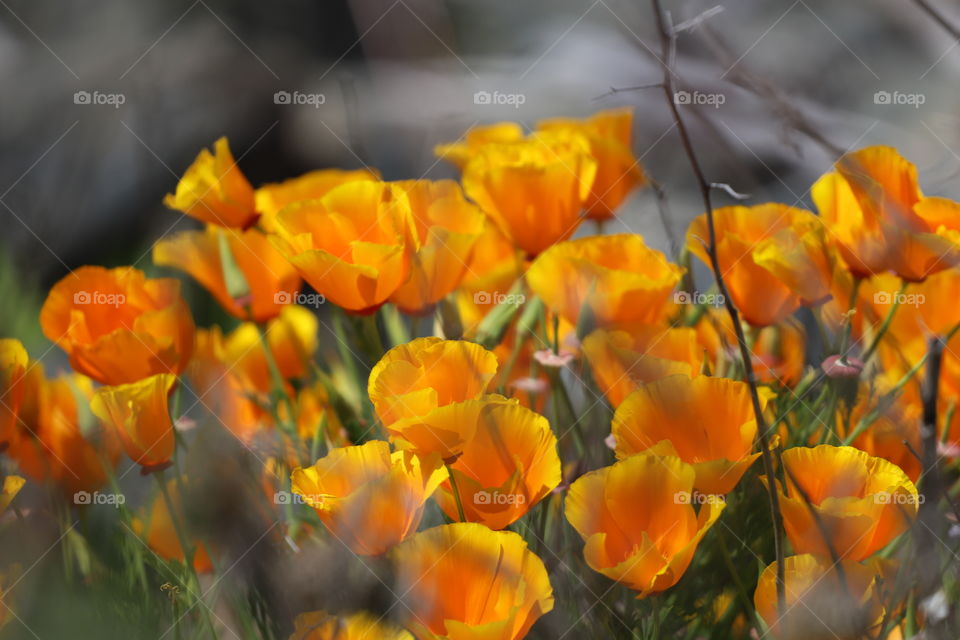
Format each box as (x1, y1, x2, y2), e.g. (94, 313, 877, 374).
(566, 455, 726, 598)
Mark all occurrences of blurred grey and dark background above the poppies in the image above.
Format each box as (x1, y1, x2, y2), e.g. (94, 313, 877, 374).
(0, 0, 960, 637)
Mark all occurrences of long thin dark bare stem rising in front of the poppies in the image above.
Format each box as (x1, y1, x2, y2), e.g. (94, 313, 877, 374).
(651, 0, 786, 616)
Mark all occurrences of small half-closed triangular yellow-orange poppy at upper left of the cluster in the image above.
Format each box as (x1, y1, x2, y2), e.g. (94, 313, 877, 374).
(163, 138, 258, 229)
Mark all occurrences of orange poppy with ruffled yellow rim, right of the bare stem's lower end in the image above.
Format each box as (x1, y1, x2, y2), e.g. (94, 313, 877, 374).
(779, 445, 920, 561)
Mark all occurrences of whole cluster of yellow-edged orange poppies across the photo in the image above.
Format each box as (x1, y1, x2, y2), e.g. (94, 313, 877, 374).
(0, 110, 960, 640)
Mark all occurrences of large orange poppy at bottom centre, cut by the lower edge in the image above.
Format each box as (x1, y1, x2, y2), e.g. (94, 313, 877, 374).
(392, 522, 553, 640)
